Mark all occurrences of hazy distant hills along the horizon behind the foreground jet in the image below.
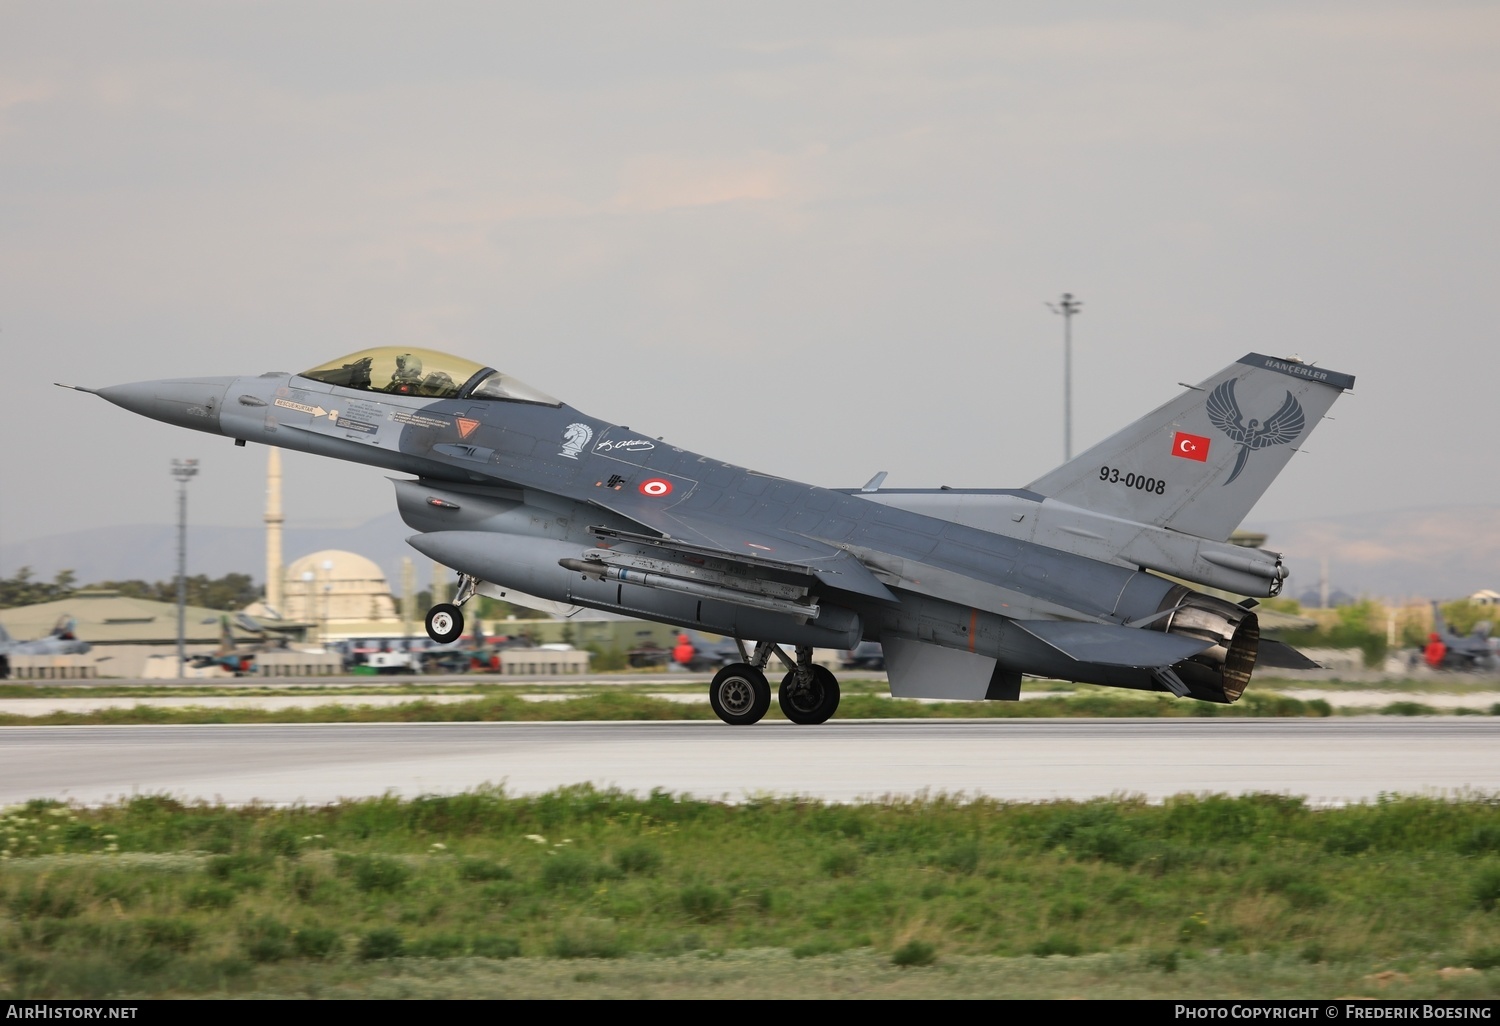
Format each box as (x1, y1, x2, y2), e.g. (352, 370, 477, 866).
(0, 506, 1500, 599)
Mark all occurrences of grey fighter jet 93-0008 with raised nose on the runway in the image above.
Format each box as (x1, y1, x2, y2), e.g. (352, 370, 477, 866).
(68, 347, 1355, 725)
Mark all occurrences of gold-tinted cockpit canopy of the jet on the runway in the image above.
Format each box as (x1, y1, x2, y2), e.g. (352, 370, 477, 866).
(302, 345, 563, 407)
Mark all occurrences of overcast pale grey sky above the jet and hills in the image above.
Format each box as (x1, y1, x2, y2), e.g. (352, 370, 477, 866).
(0, 0, 1500, 564)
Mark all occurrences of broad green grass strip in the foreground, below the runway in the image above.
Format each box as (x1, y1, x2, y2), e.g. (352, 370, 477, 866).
(0, 788, 1500, 998)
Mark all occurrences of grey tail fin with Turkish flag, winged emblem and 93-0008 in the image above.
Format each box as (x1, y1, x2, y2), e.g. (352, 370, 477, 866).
(1029, 353, 1355, 542)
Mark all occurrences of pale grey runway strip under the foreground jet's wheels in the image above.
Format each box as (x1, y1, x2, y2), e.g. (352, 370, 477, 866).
(0, 717, 1500, 804)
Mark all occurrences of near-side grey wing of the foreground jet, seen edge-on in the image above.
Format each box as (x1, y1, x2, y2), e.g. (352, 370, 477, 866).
(594, 503, 897, 602)
